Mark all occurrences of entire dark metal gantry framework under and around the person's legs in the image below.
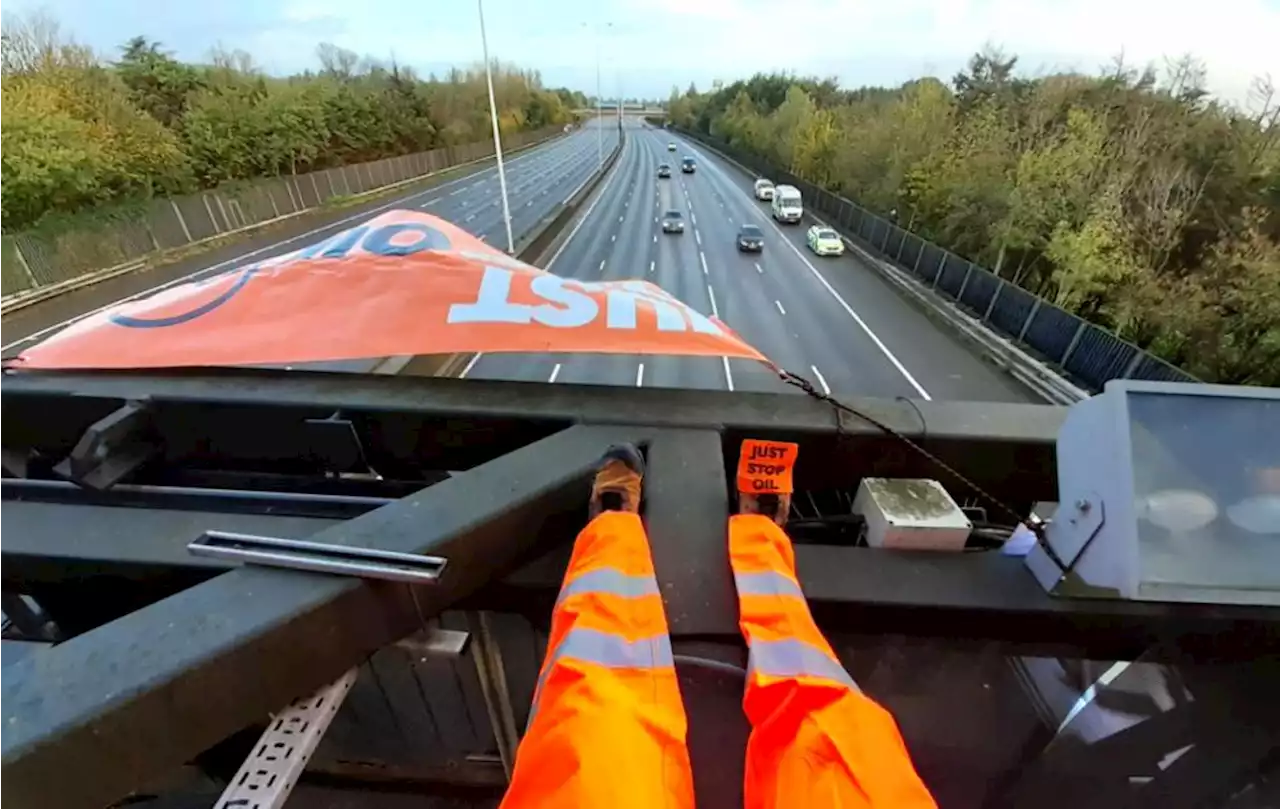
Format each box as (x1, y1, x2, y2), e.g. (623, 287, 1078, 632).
(0, 369, 1280, 809)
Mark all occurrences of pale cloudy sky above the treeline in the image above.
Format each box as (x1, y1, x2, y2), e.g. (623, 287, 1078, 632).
(10, 0, 1280, 102)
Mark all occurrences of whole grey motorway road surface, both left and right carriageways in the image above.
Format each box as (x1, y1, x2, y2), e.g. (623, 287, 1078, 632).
(0, 119, 1033, 402)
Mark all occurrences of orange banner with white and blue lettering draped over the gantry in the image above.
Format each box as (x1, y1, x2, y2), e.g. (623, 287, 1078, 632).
(14, 211, 768, 369)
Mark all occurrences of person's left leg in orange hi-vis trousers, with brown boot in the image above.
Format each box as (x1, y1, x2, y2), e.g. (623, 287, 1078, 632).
(502, 447, 694, 809)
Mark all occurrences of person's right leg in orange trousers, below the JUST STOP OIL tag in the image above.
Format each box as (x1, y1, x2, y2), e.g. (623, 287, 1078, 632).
(728, 445, 936, 809)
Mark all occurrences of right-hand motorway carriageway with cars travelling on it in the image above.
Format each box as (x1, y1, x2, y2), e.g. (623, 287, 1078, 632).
(465, 119, 1032, 402)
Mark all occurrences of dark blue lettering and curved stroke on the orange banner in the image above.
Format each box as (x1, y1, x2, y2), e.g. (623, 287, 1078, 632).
(109, 223, 452, 329)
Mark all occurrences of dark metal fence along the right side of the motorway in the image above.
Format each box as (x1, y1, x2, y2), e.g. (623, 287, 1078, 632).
(678, 129, 1201, 392)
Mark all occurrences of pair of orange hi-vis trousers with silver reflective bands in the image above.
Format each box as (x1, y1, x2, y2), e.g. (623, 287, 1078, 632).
(502, 512, 936, 809)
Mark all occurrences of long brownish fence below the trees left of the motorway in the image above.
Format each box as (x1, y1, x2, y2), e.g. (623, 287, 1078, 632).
(0, 127, 562, 298)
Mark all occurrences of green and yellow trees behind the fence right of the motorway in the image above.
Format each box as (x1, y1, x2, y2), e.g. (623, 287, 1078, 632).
(667, 51, 1280, 385)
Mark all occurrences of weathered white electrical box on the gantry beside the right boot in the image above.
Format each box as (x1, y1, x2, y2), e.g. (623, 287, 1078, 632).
(854, 477, 973, 550)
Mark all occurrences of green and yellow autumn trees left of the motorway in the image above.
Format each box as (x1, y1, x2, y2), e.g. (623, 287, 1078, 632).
(0, 15, 576, 230)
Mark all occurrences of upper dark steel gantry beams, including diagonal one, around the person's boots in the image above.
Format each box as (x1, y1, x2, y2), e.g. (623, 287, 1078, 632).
(0, 370, 1280, 809)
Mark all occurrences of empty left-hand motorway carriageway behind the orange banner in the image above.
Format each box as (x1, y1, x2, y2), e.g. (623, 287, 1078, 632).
(0, 122, 618, 355)
